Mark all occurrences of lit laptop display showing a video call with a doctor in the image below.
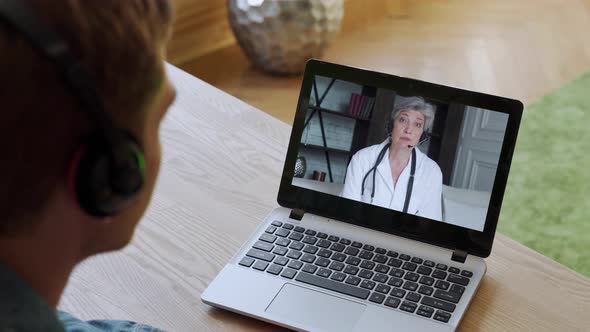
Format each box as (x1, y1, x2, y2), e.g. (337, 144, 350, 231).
(292, 75, 508, 231)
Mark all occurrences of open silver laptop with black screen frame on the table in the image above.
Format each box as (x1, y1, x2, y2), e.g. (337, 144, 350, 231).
(201, 60, 523, 332)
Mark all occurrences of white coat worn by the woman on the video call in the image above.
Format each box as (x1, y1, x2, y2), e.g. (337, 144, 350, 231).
(341, 140, 442, 221)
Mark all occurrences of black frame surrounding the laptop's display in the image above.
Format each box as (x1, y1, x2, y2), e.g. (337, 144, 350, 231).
(277, 60, 523, 257)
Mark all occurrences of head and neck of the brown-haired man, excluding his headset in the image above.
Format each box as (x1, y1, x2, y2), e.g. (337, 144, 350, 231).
(0, 0, 174, 258)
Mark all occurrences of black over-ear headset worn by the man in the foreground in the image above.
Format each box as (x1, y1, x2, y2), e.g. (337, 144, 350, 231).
(0, 0, 145, 217)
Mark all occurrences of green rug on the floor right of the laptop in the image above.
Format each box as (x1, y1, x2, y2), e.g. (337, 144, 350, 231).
(498, 72, 590, 277)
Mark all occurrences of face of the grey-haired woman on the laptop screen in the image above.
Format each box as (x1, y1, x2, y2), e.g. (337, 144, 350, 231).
(391, 110, 425, 148)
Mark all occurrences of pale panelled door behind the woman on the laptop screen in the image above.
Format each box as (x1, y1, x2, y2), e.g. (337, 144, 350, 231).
(451, 106, 508, 192)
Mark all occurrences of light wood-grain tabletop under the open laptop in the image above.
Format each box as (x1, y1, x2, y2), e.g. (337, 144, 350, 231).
(59, 66, 590, 331)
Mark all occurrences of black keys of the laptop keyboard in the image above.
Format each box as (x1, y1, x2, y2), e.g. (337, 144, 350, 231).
(239, 220, 473, 323)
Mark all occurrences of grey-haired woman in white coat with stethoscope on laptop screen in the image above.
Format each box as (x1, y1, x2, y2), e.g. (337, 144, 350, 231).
(341, 96, 442, 221)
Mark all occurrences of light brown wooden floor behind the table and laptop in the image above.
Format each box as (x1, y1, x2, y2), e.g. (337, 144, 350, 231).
(176, 0, 590, 124)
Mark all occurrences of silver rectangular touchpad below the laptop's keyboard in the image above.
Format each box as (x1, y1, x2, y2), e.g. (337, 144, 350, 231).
(266, 284, 365, 331)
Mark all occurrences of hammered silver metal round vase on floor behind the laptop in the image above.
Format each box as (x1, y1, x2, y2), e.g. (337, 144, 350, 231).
(228, 0, 344, 74)
